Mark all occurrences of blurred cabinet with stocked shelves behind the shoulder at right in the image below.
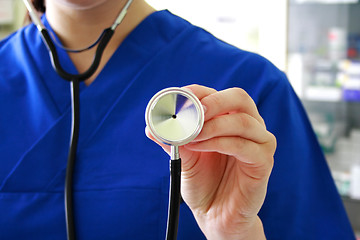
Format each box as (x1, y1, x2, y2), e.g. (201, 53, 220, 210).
(287, 0, 360, 232)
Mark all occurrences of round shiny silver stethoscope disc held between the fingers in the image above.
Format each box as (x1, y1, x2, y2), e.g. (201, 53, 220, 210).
(145, 87, 204, 146)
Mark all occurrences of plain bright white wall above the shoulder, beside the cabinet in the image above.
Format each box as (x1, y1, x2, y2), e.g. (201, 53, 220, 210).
(147, 0, 287, 70)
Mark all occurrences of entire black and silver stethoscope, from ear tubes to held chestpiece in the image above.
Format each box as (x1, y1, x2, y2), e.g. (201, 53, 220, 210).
(23, 0, 204, 240)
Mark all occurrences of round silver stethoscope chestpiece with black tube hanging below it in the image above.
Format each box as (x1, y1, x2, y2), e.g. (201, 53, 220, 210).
(145, 88, 204, 240)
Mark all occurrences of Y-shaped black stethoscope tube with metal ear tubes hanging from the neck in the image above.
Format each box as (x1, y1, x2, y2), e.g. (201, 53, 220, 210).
(24, 0, 124, 240)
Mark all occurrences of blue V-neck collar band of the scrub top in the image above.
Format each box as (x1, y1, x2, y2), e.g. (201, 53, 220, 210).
(34, 10, 190, 146)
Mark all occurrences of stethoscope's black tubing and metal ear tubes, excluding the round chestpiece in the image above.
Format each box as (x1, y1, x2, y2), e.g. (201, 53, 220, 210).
(23, 0, 181, 240)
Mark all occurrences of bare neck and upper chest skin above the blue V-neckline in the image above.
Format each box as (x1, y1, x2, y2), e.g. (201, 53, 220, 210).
(46, 0, 154, 84)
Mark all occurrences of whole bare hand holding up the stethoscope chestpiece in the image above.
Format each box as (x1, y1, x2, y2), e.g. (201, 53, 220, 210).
(147, 85, 276, 240)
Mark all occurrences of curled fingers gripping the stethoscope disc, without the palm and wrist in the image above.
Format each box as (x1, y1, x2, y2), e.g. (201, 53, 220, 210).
(147, 85, 276, 166)
